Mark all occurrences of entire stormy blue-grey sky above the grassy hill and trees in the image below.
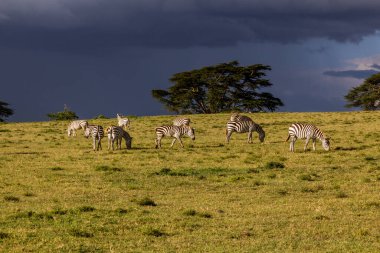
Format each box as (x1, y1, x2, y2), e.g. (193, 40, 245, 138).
(0, 0, 380, 121)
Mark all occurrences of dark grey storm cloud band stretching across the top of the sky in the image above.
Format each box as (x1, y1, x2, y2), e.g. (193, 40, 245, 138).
(0, 0, 380, 51)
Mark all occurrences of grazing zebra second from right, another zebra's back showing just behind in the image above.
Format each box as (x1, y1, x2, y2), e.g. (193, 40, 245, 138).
(226, 121, 265, 143)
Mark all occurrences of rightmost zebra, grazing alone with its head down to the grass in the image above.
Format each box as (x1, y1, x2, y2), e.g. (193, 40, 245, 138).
(286, 123, 330, 152)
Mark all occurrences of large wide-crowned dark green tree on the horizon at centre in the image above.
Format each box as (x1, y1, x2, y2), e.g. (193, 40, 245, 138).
(152, 61, 283, 113)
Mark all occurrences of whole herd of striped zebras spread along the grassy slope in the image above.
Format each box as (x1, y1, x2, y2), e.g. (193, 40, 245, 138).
(67, 113, 330, 152)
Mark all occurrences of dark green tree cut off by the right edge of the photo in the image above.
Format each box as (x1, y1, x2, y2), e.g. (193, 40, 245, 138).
(345, 73, 380, 110)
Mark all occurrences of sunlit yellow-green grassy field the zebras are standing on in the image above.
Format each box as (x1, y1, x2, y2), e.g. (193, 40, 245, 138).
(0, 112, 380, 252)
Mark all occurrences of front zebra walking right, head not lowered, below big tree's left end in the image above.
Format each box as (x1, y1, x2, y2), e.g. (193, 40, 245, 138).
(156, 125, 195, 148)
